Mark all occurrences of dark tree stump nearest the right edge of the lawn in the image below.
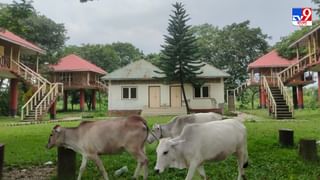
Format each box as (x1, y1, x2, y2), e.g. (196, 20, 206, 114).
(299, 139, 318, 161)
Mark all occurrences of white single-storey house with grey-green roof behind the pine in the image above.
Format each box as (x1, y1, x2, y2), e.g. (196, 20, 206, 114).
(102, 60, 229, 116)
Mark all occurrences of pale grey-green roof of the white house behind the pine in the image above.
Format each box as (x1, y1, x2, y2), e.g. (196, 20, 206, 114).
(102, 60, 230, 80)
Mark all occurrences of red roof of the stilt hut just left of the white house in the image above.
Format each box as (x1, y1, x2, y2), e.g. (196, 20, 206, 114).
(50, 54, 107, 75)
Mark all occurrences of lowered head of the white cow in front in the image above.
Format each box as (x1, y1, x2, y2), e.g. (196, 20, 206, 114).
(154, 138, 185, 173)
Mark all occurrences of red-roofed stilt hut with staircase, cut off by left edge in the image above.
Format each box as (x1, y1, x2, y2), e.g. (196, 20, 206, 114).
(0, 28, 63, 120)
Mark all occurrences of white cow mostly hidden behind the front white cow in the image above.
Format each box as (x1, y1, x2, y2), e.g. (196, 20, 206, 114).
(147, 112, 222, 143)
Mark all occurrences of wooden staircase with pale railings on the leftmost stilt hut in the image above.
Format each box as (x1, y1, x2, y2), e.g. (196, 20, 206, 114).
(7, 58, 63, 121)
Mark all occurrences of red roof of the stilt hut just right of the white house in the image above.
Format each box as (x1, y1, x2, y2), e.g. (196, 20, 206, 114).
(248, 50, 297, 70)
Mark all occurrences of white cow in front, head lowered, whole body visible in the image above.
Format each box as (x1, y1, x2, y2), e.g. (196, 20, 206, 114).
(155, 119, 248, 180)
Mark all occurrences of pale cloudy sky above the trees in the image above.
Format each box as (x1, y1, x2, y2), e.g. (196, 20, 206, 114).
(0, 0, 315, 53)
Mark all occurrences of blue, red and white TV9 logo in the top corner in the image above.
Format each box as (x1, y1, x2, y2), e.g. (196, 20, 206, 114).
(292, 8, 312, 26)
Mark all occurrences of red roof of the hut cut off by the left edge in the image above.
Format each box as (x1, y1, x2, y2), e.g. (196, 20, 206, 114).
(0, 28, 45, 54)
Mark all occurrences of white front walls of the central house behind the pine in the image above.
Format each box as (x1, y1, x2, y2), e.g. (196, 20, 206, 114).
(108, 78, 224, 110)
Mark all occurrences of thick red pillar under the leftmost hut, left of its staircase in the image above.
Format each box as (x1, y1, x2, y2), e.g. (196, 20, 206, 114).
(10, 79, 19, 117)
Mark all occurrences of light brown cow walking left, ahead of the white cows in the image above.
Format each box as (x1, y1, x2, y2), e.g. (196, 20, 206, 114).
(47, 116, 148, 180)
